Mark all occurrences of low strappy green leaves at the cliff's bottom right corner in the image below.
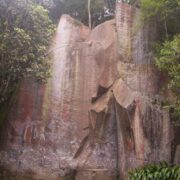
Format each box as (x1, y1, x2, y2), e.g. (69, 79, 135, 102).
(128, 162, 180, 180)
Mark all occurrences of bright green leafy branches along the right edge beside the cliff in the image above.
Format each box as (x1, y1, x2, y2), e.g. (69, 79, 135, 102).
(155, 35, 180, 119)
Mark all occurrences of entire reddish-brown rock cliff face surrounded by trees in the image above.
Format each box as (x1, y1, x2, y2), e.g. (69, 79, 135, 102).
(0, 3, 175, 180)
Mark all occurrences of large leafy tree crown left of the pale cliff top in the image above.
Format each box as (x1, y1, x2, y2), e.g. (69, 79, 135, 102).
(0, 0, 55, 104)
